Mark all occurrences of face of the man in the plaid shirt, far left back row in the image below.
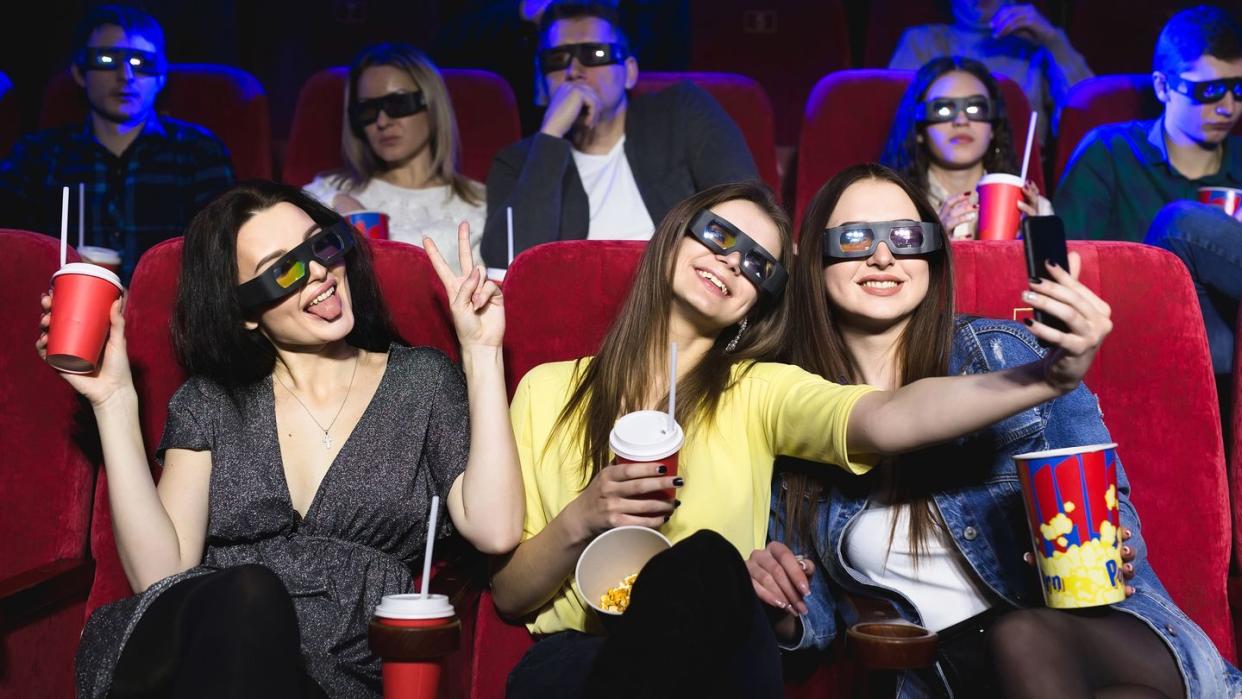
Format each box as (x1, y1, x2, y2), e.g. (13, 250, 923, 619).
(72, 25, 164, 124)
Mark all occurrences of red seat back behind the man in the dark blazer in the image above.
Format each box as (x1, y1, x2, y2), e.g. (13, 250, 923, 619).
(633, 73, 780, 194)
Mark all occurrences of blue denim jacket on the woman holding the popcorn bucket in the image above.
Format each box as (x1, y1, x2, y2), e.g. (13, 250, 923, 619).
(769, 317, 1242, 698)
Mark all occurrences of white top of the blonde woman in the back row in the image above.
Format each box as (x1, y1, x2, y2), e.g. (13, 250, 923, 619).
(304, 175, 487, 273)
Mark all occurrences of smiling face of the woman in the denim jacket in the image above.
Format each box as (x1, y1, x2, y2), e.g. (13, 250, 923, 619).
(823, 179, 930, 330)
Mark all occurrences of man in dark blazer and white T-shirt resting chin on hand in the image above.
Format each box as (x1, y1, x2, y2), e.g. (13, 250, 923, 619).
(482, 2, 758, 267)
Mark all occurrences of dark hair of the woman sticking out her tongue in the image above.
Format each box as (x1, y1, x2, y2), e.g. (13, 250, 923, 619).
(173, 181, 401, 387)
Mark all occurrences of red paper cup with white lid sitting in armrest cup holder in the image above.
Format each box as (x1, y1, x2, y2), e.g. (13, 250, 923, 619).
(375, 595, 457, 699)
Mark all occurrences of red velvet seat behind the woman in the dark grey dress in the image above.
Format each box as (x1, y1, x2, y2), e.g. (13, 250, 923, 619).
(88, 238, 473, 695)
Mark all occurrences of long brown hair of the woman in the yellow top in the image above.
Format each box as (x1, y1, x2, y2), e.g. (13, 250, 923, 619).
(549, 183, 794, 483)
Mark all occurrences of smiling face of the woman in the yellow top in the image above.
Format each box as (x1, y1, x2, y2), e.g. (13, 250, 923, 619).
(673, 200, 781, 334)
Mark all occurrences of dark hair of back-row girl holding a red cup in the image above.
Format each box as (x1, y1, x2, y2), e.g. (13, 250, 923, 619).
(879, 56, 1018, 192)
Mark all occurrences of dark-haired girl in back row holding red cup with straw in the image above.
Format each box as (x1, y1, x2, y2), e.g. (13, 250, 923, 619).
(881, 56, 1052, 240)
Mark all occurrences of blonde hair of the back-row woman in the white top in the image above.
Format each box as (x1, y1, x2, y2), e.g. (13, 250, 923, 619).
(329, 42, 483, 206)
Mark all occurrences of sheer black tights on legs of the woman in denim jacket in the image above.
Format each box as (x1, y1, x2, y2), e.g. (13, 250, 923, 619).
(987, 607, 1185, 699)
